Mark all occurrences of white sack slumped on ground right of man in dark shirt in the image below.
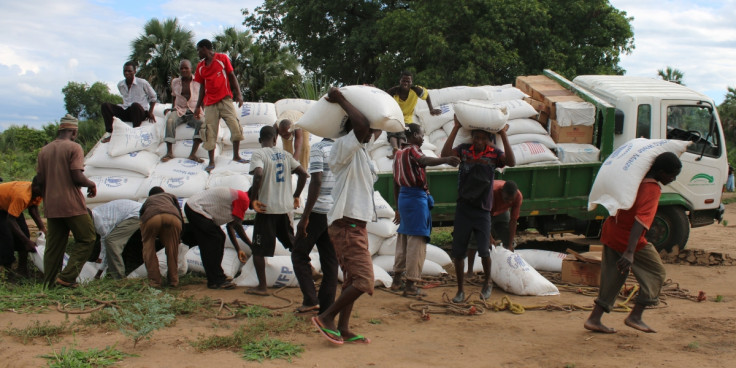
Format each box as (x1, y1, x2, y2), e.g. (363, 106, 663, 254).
(491, 246, 560, 295)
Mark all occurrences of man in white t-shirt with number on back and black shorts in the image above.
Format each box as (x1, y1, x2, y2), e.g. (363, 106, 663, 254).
(245, 126, 309, 295)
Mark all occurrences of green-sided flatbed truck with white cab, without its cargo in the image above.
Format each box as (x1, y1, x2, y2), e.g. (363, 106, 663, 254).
(375, 70, 728, 250)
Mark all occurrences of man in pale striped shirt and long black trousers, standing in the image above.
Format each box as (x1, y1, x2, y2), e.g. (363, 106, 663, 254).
(291, 138, 337, 313)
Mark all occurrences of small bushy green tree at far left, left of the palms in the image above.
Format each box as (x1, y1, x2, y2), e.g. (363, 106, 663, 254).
(61, 82, 123, 121)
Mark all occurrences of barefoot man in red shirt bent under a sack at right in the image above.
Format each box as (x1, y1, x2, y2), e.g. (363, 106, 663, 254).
(584, 152, 682, 333)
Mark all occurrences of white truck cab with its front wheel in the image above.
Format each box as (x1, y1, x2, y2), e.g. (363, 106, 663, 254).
(572, 75, 728, 250)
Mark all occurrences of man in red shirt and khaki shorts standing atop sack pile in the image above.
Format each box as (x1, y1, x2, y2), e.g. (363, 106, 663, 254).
(194, 40, 248, 172)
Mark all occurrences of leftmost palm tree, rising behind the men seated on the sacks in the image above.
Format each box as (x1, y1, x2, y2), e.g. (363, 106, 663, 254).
(130, 18, 198, 103)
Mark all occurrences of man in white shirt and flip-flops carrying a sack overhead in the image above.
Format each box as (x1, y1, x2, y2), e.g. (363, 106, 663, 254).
(312, 87, 381, 344)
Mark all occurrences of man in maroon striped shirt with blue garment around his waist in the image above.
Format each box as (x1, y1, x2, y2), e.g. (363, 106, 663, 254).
(391, 124, 460, 296)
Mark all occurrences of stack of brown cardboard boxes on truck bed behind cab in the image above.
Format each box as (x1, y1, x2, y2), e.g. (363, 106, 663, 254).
(516, 75, 593, 144)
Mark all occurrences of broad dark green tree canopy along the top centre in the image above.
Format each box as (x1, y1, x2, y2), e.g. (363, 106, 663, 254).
(243, 0, 634, 88)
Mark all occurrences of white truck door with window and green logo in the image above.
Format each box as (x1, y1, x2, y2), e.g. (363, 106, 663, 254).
(660, 100, 727, 210)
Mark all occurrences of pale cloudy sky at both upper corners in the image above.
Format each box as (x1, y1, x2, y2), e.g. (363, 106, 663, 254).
(0, 0, 736, 130)
